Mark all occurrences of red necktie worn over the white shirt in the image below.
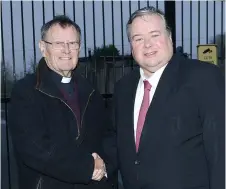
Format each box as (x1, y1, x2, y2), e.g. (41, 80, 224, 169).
(136, 80, 151, 151)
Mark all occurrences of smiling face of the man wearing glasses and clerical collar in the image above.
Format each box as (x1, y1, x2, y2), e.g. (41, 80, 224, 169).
(39, 24, 80, 76)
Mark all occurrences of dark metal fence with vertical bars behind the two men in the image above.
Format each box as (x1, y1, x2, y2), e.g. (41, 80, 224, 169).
(1, 1, 225, 189)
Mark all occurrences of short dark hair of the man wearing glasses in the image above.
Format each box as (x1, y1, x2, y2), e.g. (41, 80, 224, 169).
(41, 15, 81, 42)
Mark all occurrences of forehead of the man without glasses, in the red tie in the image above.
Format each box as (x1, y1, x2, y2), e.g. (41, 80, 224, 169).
(131, 15, 165, 35)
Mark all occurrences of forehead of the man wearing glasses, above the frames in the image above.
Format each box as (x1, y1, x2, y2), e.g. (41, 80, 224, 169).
(46, 24, 79, 41)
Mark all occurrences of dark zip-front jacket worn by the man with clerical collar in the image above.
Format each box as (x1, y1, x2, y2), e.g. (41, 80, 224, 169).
(9, 59, 116, 189)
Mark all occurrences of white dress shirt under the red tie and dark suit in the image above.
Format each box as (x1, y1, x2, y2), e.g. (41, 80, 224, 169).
(134, 64, 167, 140)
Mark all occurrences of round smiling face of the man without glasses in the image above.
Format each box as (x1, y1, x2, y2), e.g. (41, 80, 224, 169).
(130, 15, 173, 75)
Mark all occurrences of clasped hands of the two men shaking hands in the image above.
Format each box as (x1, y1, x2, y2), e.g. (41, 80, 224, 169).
(92, 153, 107, 181)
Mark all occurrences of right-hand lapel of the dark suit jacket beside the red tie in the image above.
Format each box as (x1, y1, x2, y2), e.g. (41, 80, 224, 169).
(138, 55, 179, 153)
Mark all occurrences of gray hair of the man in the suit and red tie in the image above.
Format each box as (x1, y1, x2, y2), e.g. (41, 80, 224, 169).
(126, 6, 171, 41)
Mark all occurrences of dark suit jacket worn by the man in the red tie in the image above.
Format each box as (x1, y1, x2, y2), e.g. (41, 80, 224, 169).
(114, 55, 225, 189)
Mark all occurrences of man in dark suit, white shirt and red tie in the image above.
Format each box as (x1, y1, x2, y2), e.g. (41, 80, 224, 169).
(114, 7, 225, 189)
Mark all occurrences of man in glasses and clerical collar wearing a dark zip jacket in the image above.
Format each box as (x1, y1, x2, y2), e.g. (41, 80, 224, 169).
(9, 15, 117, 189)
